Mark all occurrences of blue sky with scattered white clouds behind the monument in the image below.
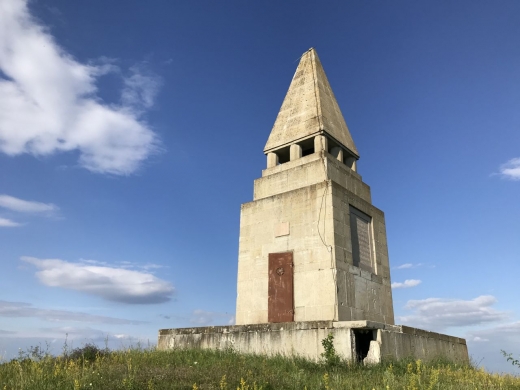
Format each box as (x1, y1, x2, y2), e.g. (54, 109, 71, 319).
(0, 0, 520, 371)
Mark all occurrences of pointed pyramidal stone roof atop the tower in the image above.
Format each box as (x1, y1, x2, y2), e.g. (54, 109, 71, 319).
(264, 48, 359, 158)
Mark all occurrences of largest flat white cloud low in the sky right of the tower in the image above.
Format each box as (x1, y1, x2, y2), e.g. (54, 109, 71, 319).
(399, 295, 507, 330)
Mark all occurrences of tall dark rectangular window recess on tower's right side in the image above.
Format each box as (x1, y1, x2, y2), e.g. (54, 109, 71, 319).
(350, 206, 374, 272)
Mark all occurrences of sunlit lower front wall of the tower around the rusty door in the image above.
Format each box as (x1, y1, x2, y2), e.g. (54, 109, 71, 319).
(236, 182, 336, 324)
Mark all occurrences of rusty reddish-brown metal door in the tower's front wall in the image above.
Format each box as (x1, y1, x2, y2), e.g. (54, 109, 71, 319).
(267, 252, 294, 322)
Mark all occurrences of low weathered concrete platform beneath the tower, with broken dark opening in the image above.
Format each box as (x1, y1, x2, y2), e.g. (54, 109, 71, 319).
(157, 321, 469, 363)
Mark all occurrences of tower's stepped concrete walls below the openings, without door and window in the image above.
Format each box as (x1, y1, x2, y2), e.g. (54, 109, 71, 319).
(236, 151, 394, 325)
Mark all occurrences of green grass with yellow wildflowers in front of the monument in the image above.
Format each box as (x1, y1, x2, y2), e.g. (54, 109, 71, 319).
(0, 349, 520, 390)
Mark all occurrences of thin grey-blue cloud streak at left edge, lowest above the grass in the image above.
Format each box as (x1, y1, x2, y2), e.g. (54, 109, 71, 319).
(0, 301, 144, 325)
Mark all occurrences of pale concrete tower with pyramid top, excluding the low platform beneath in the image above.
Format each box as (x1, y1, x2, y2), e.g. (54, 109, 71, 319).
(236, 49, 394, 324)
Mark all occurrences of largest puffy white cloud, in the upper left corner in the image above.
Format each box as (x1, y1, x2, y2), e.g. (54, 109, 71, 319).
(0, 0, 159, 175)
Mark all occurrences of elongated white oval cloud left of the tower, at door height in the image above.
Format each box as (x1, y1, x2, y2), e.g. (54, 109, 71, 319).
(21, 257, 174, 303)
